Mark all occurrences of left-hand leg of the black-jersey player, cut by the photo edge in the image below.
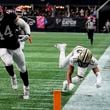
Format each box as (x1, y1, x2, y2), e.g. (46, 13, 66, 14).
(0, 48, 18, 89)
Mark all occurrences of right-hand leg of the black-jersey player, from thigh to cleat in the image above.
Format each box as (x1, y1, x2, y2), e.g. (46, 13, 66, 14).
(13, 48, 29, 99)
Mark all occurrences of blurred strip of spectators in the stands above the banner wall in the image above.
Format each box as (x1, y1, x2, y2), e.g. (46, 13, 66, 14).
(5, 3, 97, 18)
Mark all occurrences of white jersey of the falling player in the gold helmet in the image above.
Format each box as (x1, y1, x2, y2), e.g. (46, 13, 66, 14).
(69, 46, 98, 68)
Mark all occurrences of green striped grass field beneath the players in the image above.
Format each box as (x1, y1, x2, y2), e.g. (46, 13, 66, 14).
(0, 32, 110, 110)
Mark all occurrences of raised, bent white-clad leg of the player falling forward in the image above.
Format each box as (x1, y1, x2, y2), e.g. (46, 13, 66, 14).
(55, 44, 72, 68)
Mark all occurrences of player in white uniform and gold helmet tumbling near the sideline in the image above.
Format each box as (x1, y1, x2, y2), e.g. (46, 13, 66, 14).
(55, 44, 101, 92)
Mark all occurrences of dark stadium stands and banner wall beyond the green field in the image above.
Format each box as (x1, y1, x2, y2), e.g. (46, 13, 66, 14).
(0, 0, 110, 32)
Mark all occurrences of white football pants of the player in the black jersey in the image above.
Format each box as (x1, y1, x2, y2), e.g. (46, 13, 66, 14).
(0, 48, 26, 73)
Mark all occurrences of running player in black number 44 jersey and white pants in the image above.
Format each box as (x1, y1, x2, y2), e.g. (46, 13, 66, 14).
(0, 6, 30, 99)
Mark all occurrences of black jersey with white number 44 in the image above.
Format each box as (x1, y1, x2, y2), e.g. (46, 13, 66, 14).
(0, 13, 20, 50)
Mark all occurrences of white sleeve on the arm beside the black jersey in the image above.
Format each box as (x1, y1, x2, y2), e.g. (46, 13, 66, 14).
(16, 18, 31, 35)
